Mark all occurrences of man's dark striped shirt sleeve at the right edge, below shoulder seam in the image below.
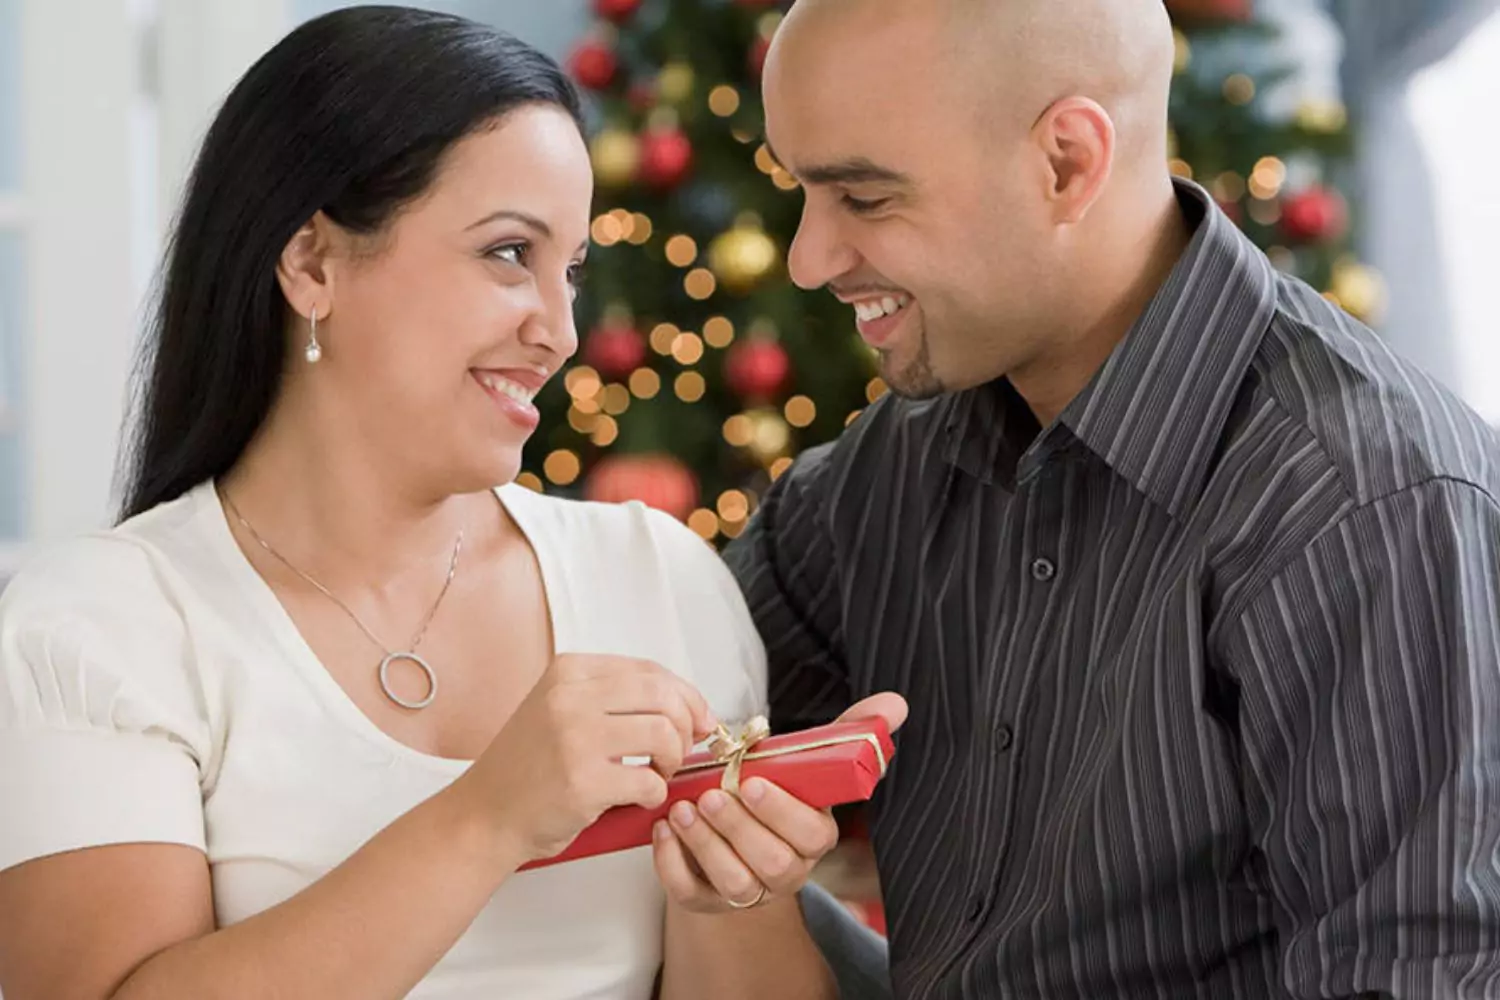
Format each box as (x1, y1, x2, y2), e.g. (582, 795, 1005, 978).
(1226, 481, 1500, 1000)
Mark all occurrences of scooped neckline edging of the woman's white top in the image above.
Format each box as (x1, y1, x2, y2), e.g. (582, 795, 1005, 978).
(198, 480, 572, 775)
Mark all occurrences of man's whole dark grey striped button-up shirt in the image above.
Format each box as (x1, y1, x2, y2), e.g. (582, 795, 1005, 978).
(728, 183, 1500, 1000)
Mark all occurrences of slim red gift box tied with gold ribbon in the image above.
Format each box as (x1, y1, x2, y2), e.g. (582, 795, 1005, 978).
(521, 717, 896, 871)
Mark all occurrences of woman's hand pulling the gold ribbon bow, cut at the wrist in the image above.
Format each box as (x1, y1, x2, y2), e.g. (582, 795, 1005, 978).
(455, 654, 717, 864)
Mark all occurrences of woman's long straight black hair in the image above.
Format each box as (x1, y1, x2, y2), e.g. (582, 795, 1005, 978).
(122, 6, 584, 517)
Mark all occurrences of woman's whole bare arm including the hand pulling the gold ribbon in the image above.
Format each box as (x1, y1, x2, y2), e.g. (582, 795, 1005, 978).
(0, 655, 711, 1000)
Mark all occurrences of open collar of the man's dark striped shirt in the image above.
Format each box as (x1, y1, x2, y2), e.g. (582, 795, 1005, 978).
(948, 178, 1277, 517)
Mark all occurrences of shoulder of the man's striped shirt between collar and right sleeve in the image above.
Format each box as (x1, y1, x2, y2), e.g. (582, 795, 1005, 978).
(1254, 279, 1500, 507)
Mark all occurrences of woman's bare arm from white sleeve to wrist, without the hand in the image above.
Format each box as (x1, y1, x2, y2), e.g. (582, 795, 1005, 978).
(0, 786, 525, 1000)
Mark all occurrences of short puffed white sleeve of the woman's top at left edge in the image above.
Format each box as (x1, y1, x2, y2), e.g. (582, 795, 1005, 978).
(0, 546, 204, 870)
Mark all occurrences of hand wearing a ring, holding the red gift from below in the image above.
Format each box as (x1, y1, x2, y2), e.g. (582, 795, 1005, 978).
(653, 691, 906, 913)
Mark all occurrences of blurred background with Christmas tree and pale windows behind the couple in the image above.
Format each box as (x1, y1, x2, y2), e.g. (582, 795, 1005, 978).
(0, 0, 1500, 925)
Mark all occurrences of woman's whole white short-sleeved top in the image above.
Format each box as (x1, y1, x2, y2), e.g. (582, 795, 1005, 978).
(0, 483, 765, 1000)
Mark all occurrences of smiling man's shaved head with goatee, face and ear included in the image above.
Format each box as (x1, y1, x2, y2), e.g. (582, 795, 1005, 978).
(765, 0, 1173, 407)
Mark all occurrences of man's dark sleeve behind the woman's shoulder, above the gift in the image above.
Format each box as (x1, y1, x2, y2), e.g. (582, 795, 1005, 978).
(725, 444, 851, 732)
